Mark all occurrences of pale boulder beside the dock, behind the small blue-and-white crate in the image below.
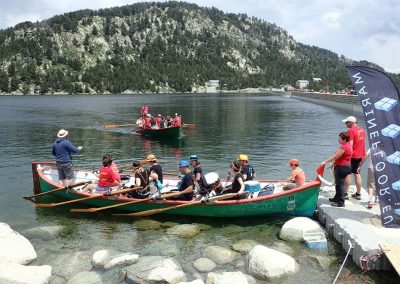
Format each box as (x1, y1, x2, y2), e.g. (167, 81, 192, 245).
(279, 217, 324, 241)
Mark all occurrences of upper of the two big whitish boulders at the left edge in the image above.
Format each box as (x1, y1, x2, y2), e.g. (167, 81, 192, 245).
(0, 223, 37, 264)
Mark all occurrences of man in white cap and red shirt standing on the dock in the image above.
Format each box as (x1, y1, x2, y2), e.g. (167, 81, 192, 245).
(342, 116, 366, 200)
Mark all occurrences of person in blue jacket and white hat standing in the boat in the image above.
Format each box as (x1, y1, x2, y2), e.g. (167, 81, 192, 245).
(52, 129, 83, 187)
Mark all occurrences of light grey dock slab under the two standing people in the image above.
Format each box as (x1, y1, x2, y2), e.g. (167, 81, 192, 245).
(318, 186, 400, 270)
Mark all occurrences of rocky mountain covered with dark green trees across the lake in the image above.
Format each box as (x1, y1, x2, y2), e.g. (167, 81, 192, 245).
(0, 2, 396, 94)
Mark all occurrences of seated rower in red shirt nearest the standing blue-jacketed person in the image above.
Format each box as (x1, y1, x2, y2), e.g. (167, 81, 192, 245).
(87, 154, 121, 194)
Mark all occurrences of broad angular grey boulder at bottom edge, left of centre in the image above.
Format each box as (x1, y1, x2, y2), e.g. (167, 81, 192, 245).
(125, 256, 186, 284)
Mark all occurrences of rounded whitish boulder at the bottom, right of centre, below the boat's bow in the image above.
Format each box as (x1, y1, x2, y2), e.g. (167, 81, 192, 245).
(248, 245, 299, 280)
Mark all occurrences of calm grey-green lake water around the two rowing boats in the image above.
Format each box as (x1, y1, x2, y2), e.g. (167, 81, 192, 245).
(0, 94, 390, 283)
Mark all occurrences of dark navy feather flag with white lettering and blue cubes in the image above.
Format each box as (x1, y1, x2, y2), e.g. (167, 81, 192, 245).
(346, 66, 400, 228)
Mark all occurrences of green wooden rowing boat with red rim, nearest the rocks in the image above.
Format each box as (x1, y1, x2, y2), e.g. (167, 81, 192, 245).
(32, 162, 321, 217)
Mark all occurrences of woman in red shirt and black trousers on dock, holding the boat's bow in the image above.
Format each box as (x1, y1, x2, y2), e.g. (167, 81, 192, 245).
(321, 131, 353, 207)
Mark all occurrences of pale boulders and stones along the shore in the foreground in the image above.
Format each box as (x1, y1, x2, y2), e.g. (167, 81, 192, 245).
(0, 217, 329, 284)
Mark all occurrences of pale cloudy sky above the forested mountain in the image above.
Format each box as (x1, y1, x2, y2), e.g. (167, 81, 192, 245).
(0, 0, 400, 73)
